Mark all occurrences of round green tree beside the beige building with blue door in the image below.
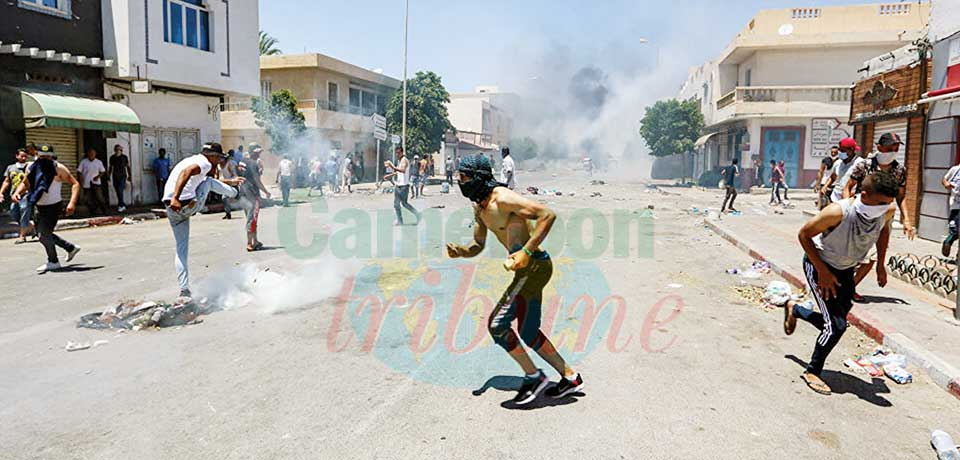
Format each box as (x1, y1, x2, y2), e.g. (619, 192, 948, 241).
(640, 99, 703, 181)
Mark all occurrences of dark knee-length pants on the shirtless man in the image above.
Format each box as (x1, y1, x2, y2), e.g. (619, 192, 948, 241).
(487, 251, 553, 352)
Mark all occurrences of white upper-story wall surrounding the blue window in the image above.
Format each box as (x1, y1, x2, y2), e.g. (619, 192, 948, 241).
(103, 0, 260, 95)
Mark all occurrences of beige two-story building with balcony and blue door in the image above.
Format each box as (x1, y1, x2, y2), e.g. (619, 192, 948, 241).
(681, 2, 930, 187)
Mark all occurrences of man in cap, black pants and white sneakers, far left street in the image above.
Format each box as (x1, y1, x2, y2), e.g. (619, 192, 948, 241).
(13, 144, 80, 274)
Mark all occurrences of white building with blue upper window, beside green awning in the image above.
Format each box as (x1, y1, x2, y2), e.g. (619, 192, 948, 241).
(103, 0, 260, 204)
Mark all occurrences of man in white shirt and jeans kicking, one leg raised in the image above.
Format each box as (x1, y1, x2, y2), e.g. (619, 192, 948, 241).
(163, 143, 244, 304)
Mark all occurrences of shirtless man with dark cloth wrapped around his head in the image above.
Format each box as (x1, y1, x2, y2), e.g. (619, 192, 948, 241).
(447, 155, 583, 405)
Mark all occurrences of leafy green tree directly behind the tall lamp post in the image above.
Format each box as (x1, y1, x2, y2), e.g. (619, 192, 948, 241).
(387, 72, 453, 156)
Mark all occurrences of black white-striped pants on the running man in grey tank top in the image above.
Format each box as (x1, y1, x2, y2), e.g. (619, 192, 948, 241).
(793, 257, 857, 375)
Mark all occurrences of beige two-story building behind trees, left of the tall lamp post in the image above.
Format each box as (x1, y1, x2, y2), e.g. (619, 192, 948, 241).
(221, 53, 401, 180)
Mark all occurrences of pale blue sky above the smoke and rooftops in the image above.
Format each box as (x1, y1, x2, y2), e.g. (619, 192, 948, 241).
(260, 0, 892, 96)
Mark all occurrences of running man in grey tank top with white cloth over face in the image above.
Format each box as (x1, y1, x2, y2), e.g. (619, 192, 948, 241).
(783, 171, 899, 395)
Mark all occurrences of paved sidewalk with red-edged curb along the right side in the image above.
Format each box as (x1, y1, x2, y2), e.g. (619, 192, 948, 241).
(704, 194, 960, 398)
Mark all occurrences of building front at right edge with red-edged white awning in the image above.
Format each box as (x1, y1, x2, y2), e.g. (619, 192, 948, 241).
(918, 1, 960, 240)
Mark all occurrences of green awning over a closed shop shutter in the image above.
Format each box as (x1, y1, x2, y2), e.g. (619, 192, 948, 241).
(20, 91, 140, 133)
